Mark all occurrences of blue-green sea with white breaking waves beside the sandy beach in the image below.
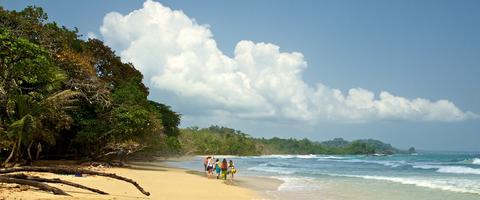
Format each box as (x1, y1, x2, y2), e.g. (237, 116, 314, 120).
(171, 152, 480, 200)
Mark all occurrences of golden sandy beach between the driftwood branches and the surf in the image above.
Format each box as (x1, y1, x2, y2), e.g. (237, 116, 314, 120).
(0, 162, 281, 200)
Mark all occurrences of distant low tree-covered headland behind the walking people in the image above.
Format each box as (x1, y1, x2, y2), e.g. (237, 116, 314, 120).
(179, 126, 415, 155)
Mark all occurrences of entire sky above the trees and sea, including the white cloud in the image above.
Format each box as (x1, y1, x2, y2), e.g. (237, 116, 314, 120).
(0, 0, 480, 151)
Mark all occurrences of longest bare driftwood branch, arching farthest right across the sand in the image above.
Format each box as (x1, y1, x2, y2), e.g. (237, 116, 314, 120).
(0, 166, 150, 196)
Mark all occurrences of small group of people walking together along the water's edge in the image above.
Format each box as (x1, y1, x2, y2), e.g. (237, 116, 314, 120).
(203, 156, 237, 181)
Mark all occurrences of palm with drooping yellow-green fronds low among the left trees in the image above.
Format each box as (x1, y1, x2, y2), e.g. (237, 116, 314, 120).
(4, 81, 81, 164)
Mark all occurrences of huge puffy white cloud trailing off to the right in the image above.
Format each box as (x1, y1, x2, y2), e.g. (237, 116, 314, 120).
(100, 1, 476, 123)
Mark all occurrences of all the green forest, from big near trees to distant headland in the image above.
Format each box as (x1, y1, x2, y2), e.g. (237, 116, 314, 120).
(0, 7, 406, 166)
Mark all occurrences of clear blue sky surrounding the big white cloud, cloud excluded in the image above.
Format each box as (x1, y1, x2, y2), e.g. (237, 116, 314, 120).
(0, 0, 480, 151)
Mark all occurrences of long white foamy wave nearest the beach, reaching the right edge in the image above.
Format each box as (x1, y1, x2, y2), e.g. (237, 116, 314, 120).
(329, 174, 480, 194)
